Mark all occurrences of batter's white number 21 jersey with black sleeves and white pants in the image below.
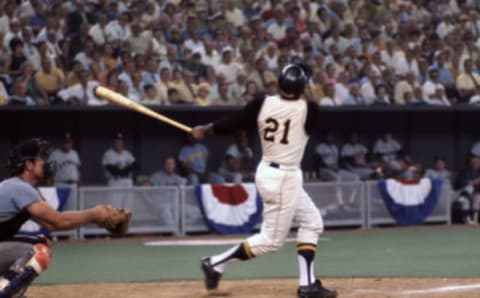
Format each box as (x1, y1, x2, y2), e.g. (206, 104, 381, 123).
(213, 96, 323, 256)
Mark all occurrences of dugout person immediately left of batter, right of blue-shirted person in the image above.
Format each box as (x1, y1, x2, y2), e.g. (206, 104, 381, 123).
(218, 130, 254, 183)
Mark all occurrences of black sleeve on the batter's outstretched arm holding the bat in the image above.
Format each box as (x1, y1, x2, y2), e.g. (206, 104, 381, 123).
(213, 94, 265, 135)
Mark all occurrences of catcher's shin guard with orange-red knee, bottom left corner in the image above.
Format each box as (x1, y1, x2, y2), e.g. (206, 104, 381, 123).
(0, 244, 50, 298)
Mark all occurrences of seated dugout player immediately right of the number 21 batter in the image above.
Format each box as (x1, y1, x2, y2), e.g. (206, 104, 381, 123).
(315, 133, 359, 181)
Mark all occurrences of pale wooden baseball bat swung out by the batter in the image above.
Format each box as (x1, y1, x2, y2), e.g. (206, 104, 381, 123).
(93, 86, 192, 133)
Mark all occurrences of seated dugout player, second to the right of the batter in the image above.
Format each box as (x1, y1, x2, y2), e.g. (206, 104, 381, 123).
(340, 133, 374, 179)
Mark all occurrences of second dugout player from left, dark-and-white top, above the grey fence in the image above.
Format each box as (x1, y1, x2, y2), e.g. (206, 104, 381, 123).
(102, 133, 135, 187)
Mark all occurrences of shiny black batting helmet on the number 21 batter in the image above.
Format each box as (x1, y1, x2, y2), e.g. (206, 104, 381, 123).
(278, 64, 311, 99)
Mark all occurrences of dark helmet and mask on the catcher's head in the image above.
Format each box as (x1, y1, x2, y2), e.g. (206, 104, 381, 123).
(8, 138, 53, 179)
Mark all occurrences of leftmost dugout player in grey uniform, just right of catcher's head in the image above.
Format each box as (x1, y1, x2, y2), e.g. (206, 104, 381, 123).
(49, 133, 81, 187)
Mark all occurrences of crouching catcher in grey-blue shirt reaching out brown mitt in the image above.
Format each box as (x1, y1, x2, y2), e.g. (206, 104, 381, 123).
(0, 139, 131, 298)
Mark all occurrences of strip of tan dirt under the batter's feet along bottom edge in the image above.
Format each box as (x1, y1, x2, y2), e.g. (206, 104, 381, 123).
(27, 278, 480, 298)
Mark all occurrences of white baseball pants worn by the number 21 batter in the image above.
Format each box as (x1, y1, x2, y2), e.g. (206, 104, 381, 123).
(247, 161, 323, 256)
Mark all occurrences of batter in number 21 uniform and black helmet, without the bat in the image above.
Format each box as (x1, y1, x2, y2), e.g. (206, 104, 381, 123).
(192, 64, 337, 298)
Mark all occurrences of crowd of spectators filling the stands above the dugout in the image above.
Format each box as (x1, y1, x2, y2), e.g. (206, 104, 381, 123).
(0, 0, 480, 106)
